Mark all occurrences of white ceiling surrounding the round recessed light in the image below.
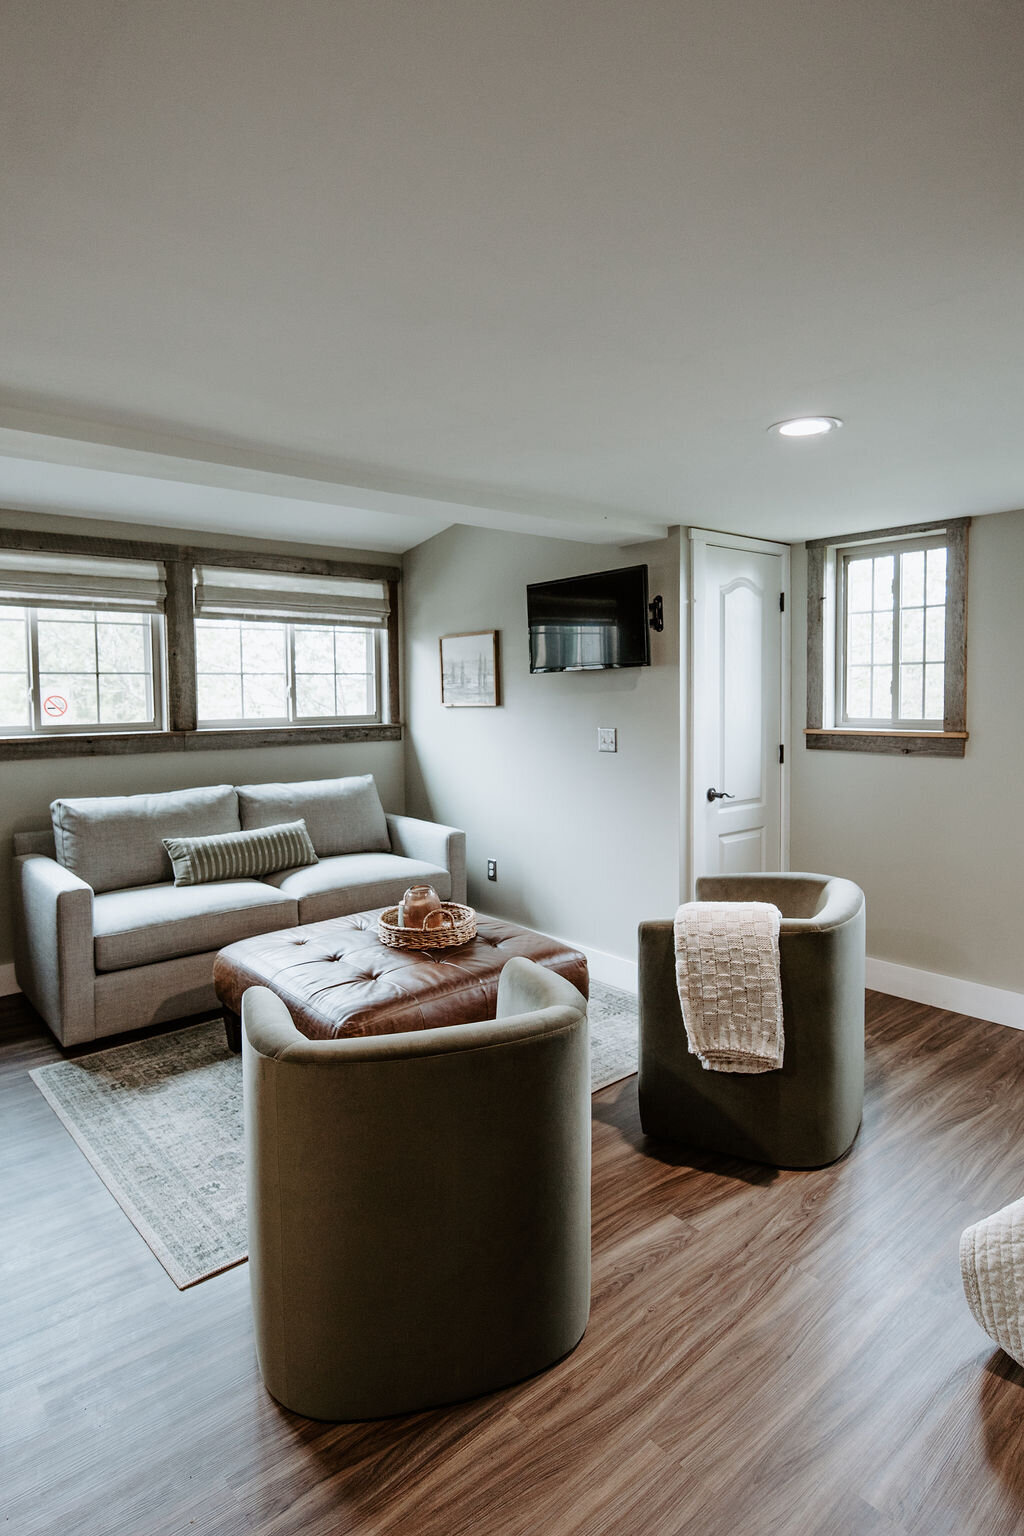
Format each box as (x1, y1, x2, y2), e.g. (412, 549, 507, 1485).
(0, 0, 1024, 550)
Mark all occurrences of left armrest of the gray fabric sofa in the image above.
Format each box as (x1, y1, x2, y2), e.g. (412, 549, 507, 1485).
(14, 854, 95, 1046)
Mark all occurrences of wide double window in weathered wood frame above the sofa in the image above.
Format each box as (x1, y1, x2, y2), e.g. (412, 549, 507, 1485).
(0, 527, 402, 762)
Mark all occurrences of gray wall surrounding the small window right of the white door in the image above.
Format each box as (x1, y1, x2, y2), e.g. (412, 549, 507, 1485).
(791, 511, 1024, 992)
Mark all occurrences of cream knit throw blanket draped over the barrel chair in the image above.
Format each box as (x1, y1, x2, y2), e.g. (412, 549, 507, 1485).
(674, 902, 785, 1072)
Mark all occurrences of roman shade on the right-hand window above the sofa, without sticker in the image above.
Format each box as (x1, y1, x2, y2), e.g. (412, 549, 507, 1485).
(195, 565, 390, 630)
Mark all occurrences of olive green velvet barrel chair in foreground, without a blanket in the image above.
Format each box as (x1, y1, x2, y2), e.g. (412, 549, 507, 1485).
(243, 957, 591, 1419)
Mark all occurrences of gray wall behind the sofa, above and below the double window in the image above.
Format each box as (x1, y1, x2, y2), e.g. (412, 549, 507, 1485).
(0, 511, 405, 966)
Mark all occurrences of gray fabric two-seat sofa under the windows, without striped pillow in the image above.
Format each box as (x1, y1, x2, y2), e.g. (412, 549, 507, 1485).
(14, 774, 465, 1046)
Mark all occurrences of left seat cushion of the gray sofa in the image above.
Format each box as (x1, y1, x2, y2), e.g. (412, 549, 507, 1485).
(92, 880, 298, 971)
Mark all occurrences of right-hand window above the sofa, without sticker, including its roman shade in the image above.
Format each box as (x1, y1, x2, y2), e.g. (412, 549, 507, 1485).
(195, 567, 388, 728)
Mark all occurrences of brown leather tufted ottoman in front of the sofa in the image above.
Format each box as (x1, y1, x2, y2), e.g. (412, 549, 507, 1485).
(213, 908, 588, 1051)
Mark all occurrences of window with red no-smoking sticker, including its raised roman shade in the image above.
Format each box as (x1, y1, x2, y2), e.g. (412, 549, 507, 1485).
(0, 550, 164, 736)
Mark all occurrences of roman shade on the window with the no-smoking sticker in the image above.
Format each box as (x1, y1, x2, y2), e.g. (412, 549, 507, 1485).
(0, 550, 166, 613)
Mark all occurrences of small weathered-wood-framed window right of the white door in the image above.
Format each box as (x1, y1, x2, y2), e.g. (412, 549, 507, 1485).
(808, 519, 967, 756)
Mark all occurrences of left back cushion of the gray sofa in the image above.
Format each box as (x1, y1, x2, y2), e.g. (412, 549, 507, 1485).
(49, 783, 239, 892)
